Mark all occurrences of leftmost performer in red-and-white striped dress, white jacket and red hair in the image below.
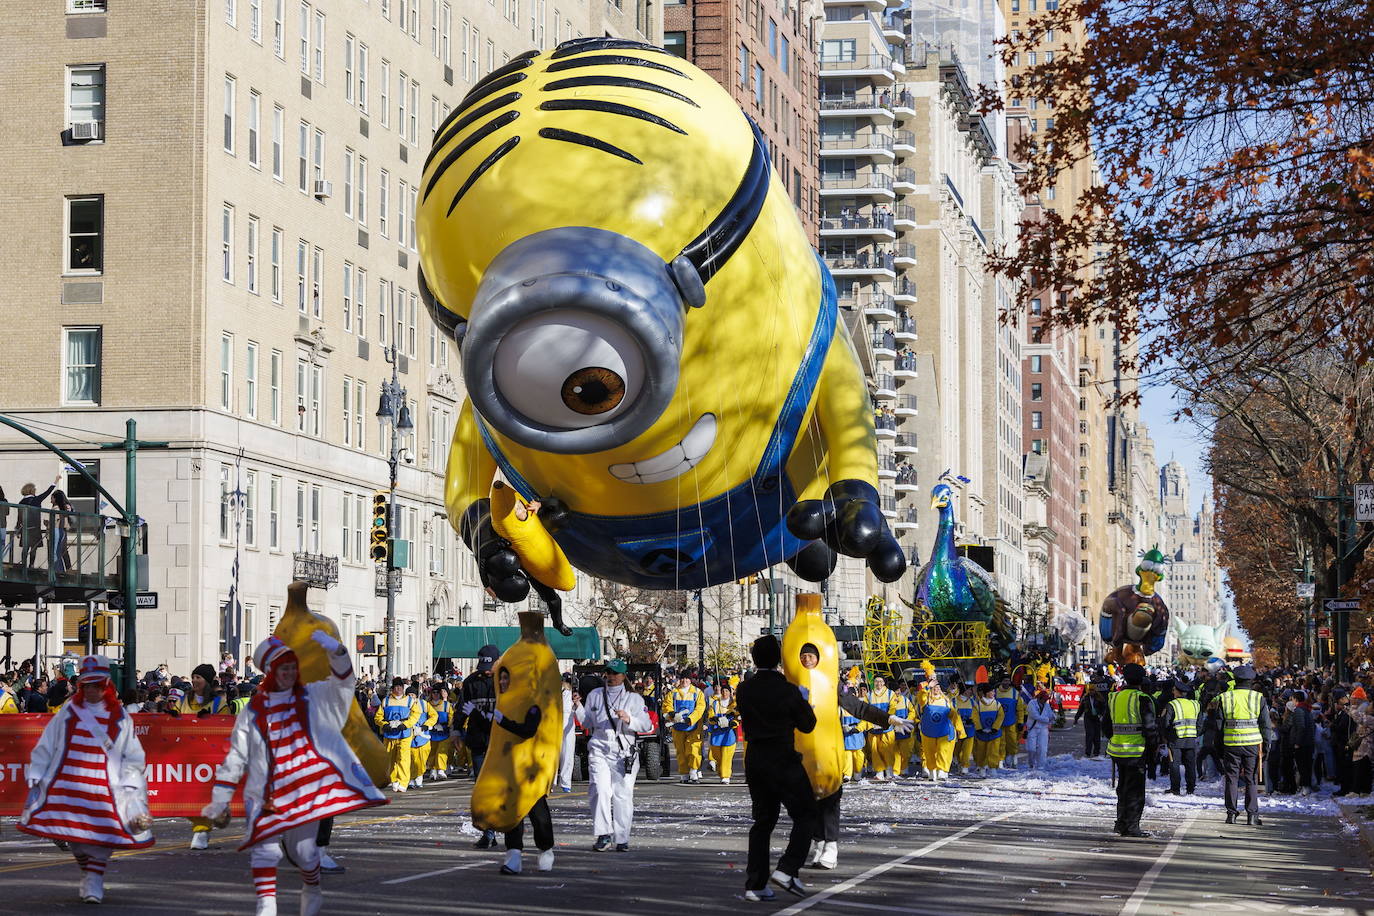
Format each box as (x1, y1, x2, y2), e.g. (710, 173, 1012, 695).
(19, 655, 153, 904)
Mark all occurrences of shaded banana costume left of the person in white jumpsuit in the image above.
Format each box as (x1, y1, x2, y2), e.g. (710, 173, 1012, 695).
(471, 612, 563, 832)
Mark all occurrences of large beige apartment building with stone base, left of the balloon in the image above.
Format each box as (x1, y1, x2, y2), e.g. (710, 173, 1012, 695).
(0, 0, 661, 673)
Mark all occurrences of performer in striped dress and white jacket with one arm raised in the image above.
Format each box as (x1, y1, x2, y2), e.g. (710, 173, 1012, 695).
(201, 630, 386, 916)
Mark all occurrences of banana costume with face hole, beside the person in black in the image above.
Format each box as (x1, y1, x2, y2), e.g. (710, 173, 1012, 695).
(782, 593, 857, 798)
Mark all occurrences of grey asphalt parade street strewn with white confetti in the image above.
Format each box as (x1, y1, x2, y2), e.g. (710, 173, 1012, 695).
(0, 732, 1374, 916)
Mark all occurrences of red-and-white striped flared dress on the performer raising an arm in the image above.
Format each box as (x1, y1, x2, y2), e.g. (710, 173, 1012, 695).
(240, 691, 373, 849)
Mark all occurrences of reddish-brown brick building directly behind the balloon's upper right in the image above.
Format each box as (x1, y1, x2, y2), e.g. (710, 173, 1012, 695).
(664, 0, 822, 244)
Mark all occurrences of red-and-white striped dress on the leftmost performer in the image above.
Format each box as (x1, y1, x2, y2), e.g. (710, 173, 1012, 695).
(19, 705, 153, 849)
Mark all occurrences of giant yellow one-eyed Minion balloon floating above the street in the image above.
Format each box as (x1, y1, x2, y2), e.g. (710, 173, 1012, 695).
(416, 38, 905, 615)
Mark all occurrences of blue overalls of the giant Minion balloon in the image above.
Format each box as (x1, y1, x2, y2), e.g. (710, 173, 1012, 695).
(477, 258, 838, 589)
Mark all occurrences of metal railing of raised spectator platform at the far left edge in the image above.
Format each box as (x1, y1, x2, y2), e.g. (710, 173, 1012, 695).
(0, 503, 121, 603)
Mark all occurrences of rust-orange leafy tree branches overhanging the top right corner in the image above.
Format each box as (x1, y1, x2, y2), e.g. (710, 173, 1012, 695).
(984, 0, 1374, 383)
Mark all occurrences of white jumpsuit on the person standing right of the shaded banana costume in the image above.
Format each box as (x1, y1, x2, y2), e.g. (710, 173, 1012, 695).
(573, 687, 650, 843)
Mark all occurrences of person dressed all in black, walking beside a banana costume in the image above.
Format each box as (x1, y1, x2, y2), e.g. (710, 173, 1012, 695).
(735, 634, 819, 901)
